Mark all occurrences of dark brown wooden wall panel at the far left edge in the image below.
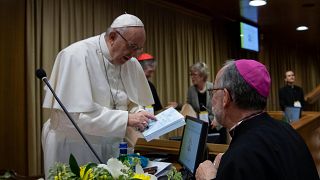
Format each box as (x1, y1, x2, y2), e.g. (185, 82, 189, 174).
(0, 0, 28, 174)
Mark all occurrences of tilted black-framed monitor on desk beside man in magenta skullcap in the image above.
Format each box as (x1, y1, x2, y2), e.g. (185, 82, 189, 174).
(178, 116, 208, 174)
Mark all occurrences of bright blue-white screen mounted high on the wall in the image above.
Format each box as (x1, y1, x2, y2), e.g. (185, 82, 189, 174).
(240, 22, 259, 52)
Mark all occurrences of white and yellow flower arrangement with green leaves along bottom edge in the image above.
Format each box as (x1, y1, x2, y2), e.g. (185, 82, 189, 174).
(48, 154, 182, 180)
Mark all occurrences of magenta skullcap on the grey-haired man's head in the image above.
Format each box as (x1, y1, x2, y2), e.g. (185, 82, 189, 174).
(235, 59, 271, 97)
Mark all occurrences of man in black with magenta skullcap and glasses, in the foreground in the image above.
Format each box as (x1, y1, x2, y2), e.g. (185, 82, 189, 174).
(196, 59, 319, 180)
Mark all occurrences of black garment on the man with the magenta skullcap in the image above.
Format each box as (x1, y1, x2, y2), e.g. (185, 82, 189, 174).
(216, 113, 319, 180)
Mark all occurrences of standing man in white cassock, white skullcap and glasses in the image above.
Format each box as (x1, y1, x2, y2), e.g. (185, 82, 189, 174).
(42, 14, 155, 176)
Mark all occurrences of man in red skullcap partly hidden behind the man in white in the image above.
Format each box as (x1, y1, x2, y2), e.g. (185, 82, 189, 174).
(138, 53, 162, 111)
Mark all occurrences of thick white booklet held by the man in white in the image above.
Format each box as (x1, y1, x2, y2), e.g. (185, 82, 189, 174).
(142, 107, 186, 142)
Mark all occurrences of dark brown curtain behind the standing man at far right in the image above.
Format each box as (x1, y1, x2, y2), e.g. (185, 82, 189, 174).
(259, 36, 320, 111)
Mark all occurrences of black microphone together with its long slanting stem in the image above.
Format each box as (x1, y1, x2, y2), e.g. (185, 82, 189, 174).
(36, 68, 103, 164)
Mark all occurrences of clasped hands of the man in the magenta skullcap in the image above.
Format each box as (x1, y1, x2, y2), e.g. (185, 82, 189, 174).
(196, 153, 223, 180)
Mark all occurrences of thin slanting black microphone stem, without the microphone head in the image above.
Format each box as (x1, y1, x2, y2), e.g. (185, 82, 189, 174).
(41, 77, 103, 164)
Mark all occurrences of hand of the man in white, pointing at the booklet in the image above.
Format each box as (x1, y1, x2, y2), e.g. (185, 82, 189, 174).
(128, 111, 156, 131)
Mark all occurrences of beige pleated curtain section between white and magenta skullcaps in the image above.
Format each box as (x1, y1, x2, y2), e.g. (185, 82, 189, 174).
(142, 1, 213, 105)
